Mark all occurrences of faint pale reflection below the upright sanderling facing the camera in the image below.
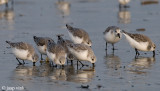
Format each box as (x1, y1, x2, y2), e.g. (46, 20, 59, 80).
(104, 53, 121, 76)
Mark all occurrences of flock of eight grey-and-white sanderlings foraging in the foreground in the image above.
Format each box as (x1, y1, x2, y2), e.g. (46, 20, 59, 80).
(6, 24, 156, 67)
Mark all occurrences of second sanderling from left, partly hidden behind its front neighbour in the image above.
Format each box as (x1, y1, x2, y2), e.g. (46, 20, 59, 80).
(33, 36, 52, 60)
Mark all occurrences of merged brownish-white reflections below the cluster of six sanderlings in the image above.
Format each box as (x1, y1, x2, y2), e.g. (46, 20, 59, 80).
(12, 64, 95, 83)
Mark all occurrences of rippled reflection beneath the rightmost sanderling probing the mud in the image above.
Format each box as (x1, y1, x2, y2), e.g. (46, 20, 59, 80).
(128, 57, 155, 74)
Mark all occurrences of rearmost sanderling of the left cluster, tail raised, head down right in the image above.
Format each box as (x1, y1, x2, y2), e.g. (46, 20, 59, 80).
(66, 24, 92, 46)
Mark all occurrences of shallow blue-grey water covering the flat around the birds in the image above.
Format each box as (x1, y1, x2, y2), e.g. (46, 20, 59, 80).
(0, 0, 160, 91)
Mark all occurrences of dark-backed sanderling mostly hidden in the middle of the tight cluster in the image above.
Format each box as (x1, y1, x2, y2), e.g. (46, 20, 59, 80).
(57, 35, 75, 64)
